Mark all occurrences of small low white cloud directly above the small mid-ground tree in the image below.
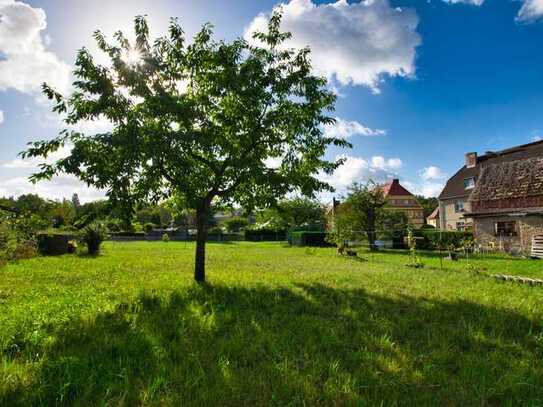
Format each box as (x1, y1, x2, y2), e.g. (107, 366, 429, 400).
(320, 155, 402, 192)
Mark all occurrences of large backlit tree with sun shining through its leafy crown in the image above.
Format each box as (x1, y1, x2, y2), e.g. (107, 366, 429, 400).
(22, 14, 349, 281)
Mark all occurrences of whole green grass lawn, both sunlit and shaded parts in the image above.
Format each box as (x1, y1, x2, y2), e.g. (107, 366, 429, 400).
(0, 242, 543, 406)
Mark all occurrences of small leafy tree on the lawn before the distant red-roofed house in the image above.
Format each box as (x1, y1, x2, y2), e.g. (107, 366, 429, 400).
(333, 180, 386, 250)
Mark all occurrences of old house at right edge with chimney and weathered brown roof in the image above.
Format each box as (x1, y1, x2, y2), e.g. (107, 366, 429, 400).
(439, 141, 543, 252)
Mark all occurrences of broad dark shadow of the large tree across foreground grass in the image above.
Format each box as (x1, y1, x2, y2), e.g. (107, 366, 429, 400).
(0, 284, 543, 406)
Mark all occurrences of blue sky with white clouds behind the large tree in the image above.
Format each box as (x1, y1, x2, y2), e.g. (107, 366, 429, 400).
(0, 0, 543, 201)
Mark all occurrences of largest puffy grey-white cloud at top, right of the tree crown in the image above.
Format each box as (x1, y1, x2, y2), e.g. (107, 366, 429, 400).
(245, 0, 421, 92)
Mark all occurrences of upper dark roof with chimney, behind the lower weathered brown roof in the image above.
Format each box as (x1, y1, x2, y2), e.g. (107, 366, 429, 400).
(439, 141, 543, 200)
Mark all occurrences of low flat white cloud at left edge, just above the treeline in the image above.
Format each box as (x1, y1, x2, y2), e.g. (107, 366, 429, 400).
(0, 175, 105, 202)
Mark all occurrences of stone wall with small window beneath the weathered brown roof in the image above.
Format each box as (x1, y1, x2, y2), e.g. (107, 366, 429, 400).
(474, 215, 543, 254)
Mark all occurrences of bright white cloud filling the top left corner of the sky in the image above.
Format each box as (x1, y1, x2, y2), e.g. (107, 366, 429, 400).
(0, 0, 70, 95)
